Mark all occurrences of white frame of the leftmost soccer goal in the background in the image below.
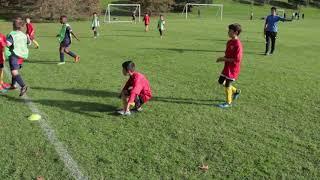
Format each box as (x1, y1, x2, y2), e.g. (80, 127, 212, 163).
(104, 4, 141, 23)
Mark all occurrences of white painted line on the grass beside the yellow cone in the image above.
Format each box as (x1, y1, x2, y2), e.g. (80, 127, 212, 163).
(5, 67, 88, 180)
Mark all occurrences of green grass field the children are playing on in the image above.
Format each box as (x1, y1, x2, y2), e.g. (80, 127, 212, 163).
(0, 0, 320, 179)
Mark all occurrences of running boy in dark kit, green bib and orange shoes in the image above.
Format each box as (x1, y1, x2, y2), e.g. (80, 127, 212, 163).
(57, 16, 80, 65)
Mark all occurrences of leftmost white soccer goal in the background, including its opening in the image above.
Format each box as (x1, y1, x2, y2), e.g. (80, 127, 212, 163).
(104, 4, 141, 23)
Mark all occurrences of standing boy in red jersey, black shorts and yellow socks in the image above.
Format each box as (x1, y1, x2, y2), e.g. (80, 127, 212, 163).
(217, 24, 243, 108)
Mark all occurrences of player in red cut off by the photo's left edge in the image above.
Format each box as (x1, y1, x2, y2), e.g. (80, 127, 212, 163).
(0, 33, 10, 91)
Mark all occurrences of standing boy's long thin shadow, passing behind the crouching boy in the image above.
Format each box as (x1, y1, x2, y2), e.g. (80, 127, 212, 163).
(32, 87, 224, 106)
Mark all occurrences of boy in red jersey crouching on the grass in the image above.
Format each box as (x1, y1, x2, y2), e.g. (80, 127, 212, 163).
(118, 61, 152, 115)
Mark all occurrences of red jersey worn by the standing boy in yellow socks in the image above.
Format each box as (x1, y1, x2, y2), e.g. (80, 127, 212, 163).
(221, 39, 242, 80)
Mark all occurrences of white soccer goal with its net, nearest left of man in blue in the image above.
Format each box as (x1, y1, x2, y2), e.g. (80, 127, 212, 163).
(182, 3, 223, 20)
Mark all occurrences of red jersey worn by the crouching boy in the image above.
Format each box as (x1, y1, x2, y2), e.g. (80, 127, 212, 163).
(123, 72, 152, 103)
